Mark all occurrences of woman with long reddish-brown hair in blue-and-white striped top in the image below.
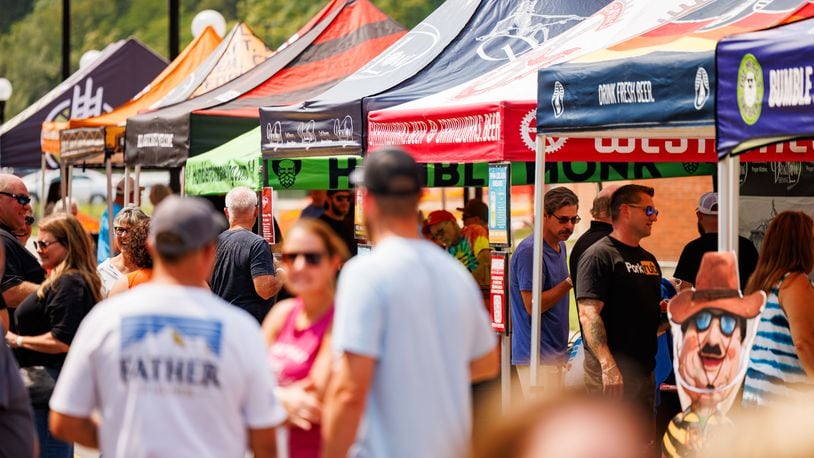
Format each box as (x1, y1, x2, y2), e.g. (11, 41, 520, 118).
(743, 211, 814, 406)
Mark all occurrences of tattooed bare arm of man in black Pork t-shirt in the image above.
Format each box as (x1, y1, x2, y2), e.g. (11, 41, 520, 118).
(578, 298, 624, 396)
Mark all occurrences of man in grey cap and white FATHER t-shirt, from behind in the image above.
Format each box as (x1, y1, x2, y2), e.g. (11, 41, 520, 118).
(50, 196, 285, 457)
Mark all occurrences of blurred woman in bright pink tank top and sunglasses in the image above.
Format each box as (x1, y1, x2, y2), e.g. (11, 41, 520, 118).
(263, 218, 349, 458)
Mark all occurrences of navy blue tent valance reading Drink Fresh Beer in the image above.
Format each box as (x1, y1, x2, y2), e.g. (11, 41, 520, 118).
(537, 52, 715, 133)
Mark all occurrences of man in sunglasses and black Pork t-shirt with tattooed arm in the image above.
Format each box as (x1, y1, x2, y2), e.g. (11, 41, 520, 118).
(577, 185, 661, 415)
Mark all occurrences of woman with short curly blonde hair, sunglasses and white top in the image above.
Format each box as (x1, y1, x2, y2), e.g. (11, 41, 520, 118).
(97, 207, 150, 297)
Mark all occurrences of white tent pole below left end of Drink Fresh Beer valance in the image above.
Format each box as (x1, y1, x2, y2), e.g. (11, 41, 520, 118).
(529, 134, 545, 393)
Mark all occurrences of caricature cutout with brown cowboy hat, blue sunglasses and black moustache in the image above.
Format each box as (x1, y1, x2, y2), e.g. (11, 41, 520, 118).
(662, 252, 766, 457)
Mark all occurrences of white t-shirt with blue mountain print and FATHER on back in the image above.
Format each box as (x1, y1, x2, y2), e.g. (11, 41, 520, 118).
(50, 284, 286, 458)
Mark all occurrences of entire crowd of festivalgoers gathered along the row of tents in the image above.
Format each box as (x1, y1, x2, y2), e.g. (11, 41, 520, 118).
(0, 149, 814, 458)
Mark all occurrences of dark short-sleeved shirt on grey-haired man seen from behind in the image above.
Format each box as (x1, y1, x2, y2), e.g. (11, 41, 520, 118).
(210, 229, 276, 322)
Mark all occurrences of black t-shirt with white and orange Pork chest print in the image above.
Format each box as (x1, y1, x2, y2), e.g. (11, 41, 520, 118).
(577, 236, 661, 385)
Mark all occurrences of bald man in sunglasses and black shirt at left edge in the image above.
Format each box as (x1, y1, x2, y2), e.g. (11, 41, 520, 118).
(0, 173, 45, 330)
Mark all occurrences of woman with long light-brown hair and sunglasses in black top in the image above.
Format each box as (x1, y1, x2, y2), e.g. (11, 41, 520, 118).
(6, 213, 101, 457)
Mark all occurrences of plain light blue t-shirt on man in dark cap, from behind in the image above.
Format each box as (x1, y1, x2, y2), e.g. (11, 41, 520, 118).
(332, 237, 496, 458)
